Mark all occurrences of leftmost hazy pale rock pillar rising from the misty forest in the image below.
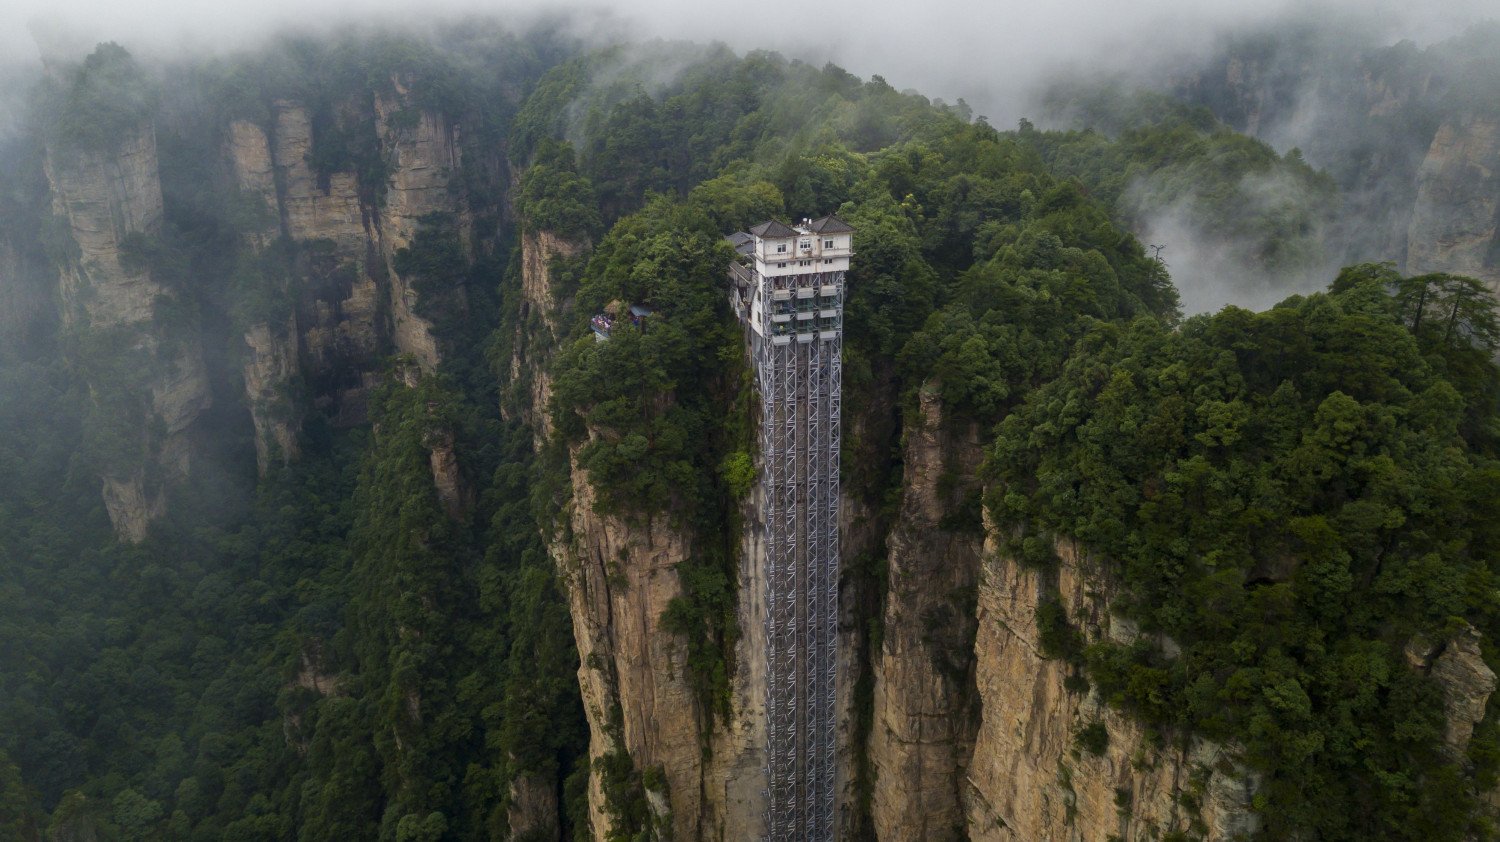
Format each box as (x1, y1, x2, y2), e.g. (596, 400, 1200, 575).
(47, 123, 212, 542)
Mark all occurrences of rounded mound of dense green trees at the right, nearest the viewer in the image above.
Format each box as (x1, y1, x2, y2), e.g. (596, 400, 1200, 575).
(990, 266, 1500, 839)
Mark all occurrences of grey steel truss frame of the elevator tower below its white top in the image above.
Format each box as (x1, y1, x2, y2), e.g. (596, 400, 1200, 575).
(755, 265, 845, 842)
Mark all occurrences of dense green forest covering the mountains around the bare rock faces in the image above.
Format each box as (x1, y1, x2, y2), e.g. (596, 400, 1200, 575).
(0, 19, 1500, 842)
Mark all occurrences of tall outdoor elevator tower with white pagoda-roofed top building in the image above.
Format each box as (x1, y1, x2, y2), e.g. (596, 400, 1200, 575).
(732, 216, 854, 842)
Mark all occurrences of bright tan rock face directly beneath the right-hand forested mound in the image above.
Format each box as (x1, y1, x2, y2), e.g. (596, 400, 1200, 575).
(965, 540, 1259, 842)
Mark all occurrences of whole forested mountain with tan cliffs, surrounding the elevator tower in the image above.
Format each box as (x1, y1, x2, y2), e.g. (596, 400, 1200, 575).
(0, 20, 1500, 842)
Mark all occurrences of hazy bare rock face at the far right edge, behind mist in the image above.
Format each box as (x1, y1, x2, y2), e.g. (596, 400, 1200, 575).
(1407, 113, 1500, 291)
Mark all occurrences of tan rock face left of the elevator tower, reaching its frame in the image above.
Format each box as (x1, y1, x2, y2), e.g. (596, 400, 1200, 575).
(512, 231, 765, 840)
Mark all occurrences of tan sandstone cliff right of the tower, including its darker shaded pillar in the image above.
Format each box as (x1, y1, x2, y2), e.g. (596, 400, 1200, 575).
(866, 389, 1256, 842)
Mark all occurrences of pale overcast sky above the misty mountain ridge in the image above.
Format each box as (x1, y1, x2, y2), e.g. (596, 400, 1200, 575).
(0, 0, 1500, 126)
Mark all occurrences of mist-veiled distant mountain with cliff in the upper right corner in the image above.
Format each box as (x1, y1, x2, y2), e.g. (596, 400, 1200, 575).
(1176, 32, 1500, 291)
